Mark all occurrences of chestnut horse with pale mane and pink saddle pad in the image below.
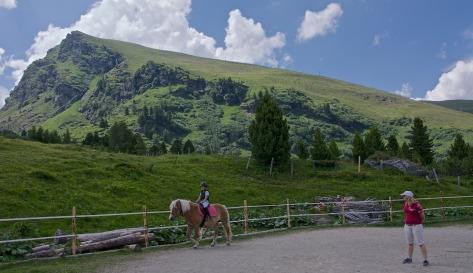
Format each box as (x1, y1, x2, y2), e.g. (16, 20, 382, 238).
(169, 199, 232, 248)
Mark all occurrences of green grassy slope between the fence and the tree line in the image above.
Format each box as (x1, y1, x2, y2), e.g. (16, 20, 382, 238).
(0, 138, 473, 235)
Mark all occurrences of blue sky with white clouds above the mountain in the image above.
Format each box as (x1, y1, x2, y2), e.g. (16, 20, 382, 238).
(0, 0, 473, 107)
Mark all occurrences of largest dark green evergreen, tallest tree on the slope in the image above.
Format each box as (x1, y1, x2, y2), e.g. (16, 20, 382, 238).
(249, 91, 291, 165)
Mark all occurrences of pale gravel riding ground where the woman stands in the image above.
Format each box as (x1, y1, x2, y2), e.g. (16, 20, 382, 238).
(100, 225, 473, 273)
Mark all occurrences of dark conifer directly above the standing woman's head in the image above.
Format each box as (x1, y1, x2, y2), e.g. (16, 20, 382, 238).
(407, 118, 434, 165)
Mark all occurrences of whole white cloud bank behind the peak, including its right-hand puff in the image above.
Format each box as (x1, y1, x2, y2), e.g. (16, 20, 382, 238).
(7, 0, 285, 82)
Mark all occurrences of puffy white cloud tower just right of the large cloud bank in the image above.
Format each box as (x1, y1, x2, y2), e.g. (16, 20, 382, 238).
(215, 9, 286, 66)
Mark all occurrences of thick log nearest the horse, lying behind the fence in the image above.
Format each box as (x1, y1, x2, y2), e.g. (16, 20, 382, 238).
(79, 232, 154, 253)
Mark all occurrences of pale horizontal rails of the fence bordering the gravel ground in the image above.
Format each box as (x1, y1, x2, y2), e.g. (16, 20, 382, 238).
(0, 196, 473, 244)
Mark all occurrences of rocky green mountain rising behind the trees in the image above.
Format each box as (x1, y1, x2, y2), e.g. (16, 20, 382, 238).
(0, 31, 473, 153)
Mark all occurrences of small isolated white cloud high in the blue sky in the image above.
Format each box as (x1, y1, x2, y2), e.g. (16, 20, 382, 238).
(297, 3, 343, 42)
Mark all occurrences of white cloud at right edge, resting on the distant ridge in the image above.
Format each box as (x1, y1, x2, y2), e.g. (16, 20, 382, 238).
(425, 59, 473, 101)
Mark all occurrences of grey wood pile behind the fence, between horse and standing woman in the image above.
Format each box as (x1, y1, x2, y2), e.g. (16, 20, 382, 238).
(317, 196, 389, 224)
